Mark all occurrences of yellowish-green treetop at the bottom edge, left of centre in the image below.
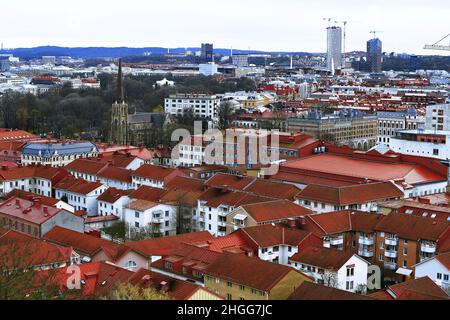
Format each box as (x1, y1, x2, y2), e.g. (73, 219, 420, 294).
(101, 283, 170, 300)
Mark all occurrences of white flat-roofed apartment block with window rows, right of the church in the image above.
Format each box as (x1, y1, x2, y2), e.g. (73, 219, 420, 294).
(164, 94, 220, 122)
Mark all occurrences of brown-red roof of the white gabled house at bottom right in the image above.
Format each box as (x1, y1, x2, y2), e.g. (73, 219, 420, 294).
(289, 247, 360, 270)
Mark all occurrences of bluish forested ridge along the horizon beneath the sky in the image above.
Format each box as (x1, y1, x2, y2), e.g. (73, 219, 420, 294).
(0, 46, 324, 59)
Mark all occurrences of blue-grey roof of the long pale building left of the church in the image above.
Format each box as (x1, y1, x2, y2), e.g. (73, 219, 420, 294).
(22, 142, 98, 157)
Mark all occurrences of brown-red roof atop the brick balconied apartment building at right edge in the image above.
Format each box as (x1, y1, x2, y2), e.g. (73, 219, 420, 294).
(375, 214, 450, 241)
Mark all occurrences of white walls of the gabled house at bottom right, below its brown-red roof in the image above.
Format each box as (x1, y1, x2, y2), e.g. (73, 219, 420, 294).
(289, 254, 369, 292)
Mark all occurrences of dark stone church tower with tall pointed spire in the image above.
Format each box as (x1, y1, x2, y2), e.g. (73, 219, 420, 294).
(111, 59, 128, 145)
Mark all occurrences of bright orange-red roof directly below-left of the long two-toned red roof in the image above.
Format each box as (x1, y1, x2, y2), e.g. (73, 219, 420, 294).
(241, 200, 312, 222)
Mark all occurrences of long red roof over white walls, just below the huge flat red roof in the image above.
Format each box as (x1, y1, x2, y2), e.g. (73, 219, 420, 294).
(297, 182, 404, 205)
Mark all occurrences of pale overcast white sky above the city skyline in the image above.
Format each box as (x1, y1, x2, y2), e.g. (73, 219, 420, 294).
(0, 0, 450, 54)
